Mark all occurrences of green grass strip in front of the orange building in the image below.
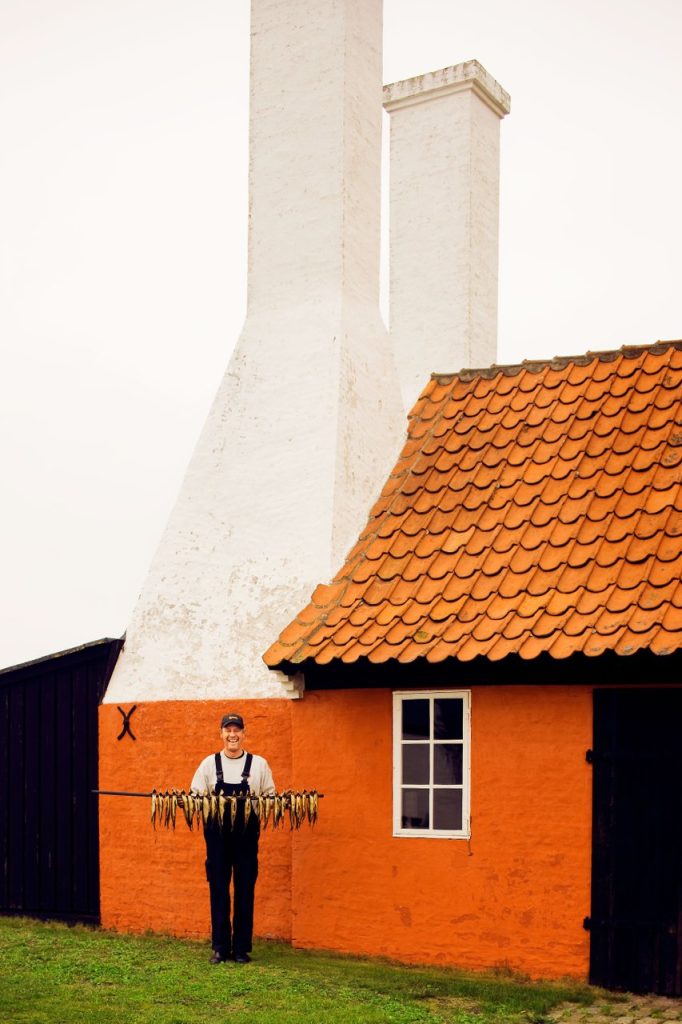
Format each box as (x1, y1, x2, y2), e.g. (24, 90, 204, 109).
(0, 918, 595, 1024)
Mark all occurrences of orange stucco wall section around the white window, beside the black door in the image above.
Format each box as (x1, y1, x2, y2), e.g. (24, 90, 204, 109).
(293, 687, 592, 978)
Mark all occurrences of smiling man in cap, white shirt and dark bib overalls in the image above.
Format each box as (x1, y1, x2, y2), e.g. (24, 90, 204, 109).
(191, 713, 275, 964)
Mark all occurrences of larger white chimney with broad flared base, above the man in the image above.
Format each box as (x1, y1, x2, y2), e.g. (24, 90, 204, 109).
(105, 0, 403, 702)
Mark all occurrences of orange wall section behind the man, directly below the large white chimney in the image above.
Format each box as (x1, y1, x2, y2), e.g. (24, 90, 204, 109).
(99, 700, 292, 940)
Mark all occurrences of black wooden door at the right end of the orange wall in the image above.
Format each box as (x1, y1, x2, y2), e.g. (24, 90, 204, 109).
(590, 689, 682, 995)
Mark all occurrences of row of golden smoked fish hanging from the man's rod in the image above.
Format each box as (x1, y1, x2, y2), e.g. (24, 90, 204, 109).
(152, 790, 319, 829)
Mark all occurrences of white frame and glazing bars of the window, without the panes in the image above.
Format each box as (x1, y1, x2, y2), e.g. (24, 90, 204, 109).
(393, 690, 471, 840)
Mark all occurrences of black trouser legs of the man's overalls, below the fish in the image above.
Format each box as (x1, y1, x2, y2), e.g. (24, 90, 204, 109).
(204, 818, 260, 956)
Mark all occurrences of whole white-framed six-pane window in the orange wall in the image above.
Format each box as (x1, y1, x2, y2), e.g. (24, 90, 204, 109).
(393, 690, 471, 839)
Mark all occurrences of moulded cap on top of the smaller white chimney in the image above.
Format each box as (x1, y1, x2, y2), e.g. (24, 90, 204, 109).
(384, 60, 503, 119)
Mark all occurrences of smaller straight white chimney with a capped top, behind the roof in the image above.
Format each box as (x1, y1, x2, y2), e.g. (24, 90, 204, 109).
(384, 60, 510, 409)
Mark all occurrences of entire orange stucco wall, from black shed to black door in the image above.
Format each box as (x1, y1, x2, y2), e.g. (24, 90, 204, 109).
(100, 686, 592, 978)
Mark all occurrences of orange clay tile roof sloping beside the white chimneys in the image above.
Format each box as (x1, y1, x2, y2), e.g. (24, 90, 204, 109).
(264, 341, 682, 668)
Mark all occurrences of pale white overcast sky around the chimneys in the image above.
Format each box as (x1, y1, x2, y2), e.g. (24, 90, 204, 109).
(0, 0, 682, 667)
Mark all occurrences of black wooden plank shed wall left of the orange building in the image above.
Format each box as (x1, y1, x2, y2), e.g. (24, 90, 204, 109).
(0, 639, 122, 922)
